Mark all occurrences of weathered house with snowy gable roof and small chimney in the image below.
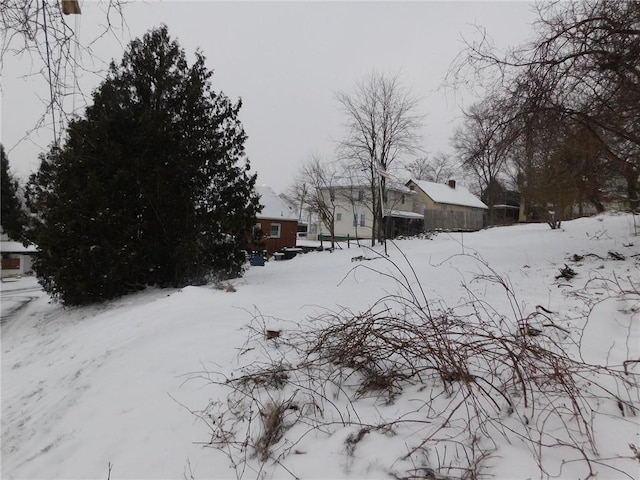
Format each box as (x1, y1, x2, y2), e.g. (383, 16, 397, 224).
(407, 180, 488, 231)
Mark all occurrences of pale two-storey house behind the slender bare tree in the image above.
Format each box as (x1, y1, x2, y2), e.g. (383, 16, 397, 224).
(318, 179, 423, 240)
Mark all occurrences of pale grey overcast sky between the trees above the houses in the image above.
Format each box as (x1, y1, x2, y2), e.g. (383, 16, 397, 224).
(1, 1, 535, 192)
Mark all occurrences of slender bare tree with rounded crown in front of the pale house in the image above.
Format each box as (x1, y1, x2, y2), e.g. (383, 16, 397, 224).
(336, 71, 422, 245)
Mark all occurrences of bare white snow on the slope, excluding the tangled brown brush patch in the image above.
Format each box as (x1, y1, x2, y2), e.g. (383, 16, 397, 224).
(1, 214, 640, 479)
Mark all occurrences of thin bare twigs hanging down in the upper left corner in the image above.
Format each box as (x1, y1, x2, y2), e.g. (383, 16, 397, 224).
(0, 0, 126, 142)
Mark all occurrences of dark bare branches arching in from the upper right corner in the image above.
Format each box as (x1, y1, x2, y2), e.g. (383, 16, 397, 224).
(449, 0, 640, 209)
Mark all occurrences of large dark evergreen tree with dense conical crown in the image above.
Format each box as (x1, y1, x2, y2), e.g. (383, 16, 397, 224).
(29, 26, 259, 304)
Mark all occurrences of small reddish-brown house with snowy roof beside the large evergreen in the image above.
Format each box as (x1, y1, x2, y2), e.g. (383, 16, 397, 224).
(251, 186, 298, 253)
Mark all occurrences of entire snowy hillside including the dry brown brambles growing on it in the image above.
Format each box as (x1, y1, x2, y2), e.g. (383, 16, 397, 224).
(1, 214, 640, 479)
